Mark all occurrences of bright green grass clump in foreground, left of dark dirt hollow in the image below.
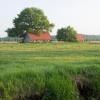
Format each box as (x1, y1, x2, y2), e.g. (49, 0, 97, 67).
(46, 73, 79, 100)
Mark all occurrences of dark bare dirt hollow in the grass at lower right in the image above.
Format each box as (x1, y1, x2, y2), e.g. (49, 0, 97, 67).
(74, 76, 94, 100)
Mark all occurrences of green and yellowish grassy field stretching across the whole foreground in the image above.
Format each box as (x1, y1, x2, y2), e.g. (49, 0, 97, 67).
(0, 43, 100, 100)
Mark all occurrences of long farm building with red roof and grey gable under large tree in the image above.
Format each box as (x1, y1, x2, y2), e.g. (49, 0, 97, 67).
(24, 32, 52, 42)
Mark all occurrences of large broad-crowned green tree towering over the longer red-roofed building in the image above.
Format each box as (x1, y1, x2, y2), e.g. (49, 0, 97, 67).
(6, 8, 54, 37)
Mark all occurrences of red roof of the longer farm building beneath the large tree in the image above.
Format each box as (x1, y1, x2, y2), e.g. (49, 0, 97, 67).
(28, 32, 51, 41)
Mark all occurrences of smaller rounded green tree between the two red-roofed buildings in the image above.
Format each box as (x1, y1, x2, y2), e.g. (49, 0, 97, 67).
(56, 26, 77, 42)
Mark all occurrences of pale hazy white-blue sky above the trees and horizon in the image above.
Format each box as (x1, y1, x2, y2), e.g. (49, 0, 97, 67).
(0, 0, 100, 37)
